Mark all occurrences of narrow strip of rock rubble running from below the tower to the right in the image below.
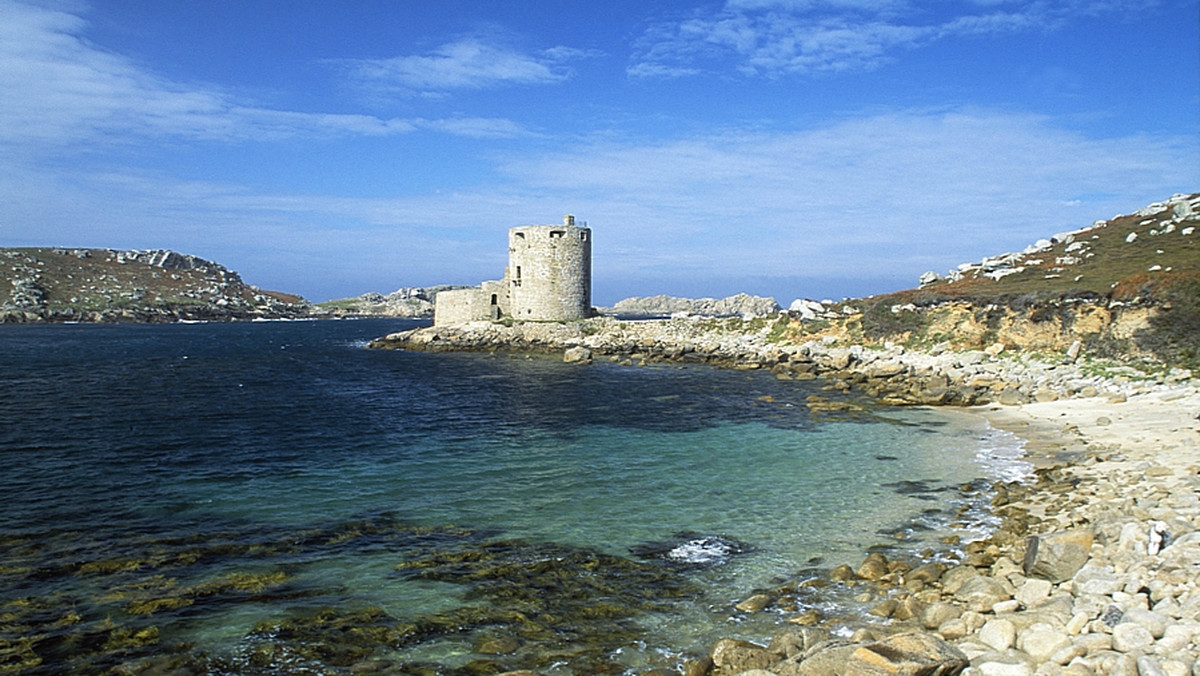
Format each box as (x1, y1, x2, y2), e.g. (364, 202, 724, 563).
(372, 315, 1192, 406)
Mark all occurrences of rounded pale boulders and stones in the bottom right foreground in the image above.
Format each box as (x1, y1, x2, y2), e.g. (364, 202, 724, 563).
(686, 445, 1200, 676)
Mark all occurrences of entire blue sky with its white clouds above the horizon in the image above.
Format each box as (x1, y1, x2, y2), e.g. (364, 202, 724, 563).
(0, 0, 1200, 305)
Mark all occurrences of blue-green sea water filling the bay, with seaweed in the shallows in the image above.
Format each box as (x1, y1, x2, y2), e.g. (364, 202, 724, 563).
(0, 321, 1020, 674)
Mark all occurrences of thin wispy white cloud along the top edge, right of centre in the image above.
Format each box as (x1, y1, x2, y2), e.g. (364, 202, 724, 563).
(626, 0, 1154, 78)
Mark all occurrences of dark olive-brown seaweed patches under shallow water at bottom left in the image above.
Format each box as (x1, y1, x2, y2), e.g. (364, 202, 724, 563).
(0, 516, 700, 675)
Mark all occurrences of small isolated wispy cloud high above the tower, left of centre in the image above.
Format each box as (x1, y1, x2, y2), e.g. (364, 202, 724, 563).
(342, 37, 586, 94)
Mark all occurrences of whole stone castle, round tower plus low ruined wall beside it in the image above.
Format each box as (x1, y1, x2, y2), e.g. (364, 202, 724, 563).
(433, 215, 592, 327)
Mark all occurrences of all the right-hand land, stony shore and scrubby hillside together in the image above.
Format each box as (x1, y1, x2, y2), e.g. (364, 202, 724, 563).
(372, 195, 1200, 676)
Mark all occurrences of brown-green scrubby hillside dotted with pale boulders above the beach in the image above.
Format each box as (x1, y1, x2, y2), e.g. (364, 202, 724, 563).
(778, 193, 1200, 372)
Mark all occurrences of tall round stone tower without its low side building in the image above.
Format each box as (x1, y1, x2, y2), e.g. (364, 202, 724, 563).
(505, 216, 592, 321)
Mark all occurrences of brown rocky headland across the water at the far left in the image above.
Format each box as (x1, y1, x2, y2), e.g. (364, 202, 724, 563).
(0, 247, 313, 323)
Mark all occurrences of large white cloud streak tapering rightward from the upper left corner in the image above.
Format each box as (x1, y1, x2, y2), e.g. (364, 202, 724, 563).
(0, 0, 523, 150)
